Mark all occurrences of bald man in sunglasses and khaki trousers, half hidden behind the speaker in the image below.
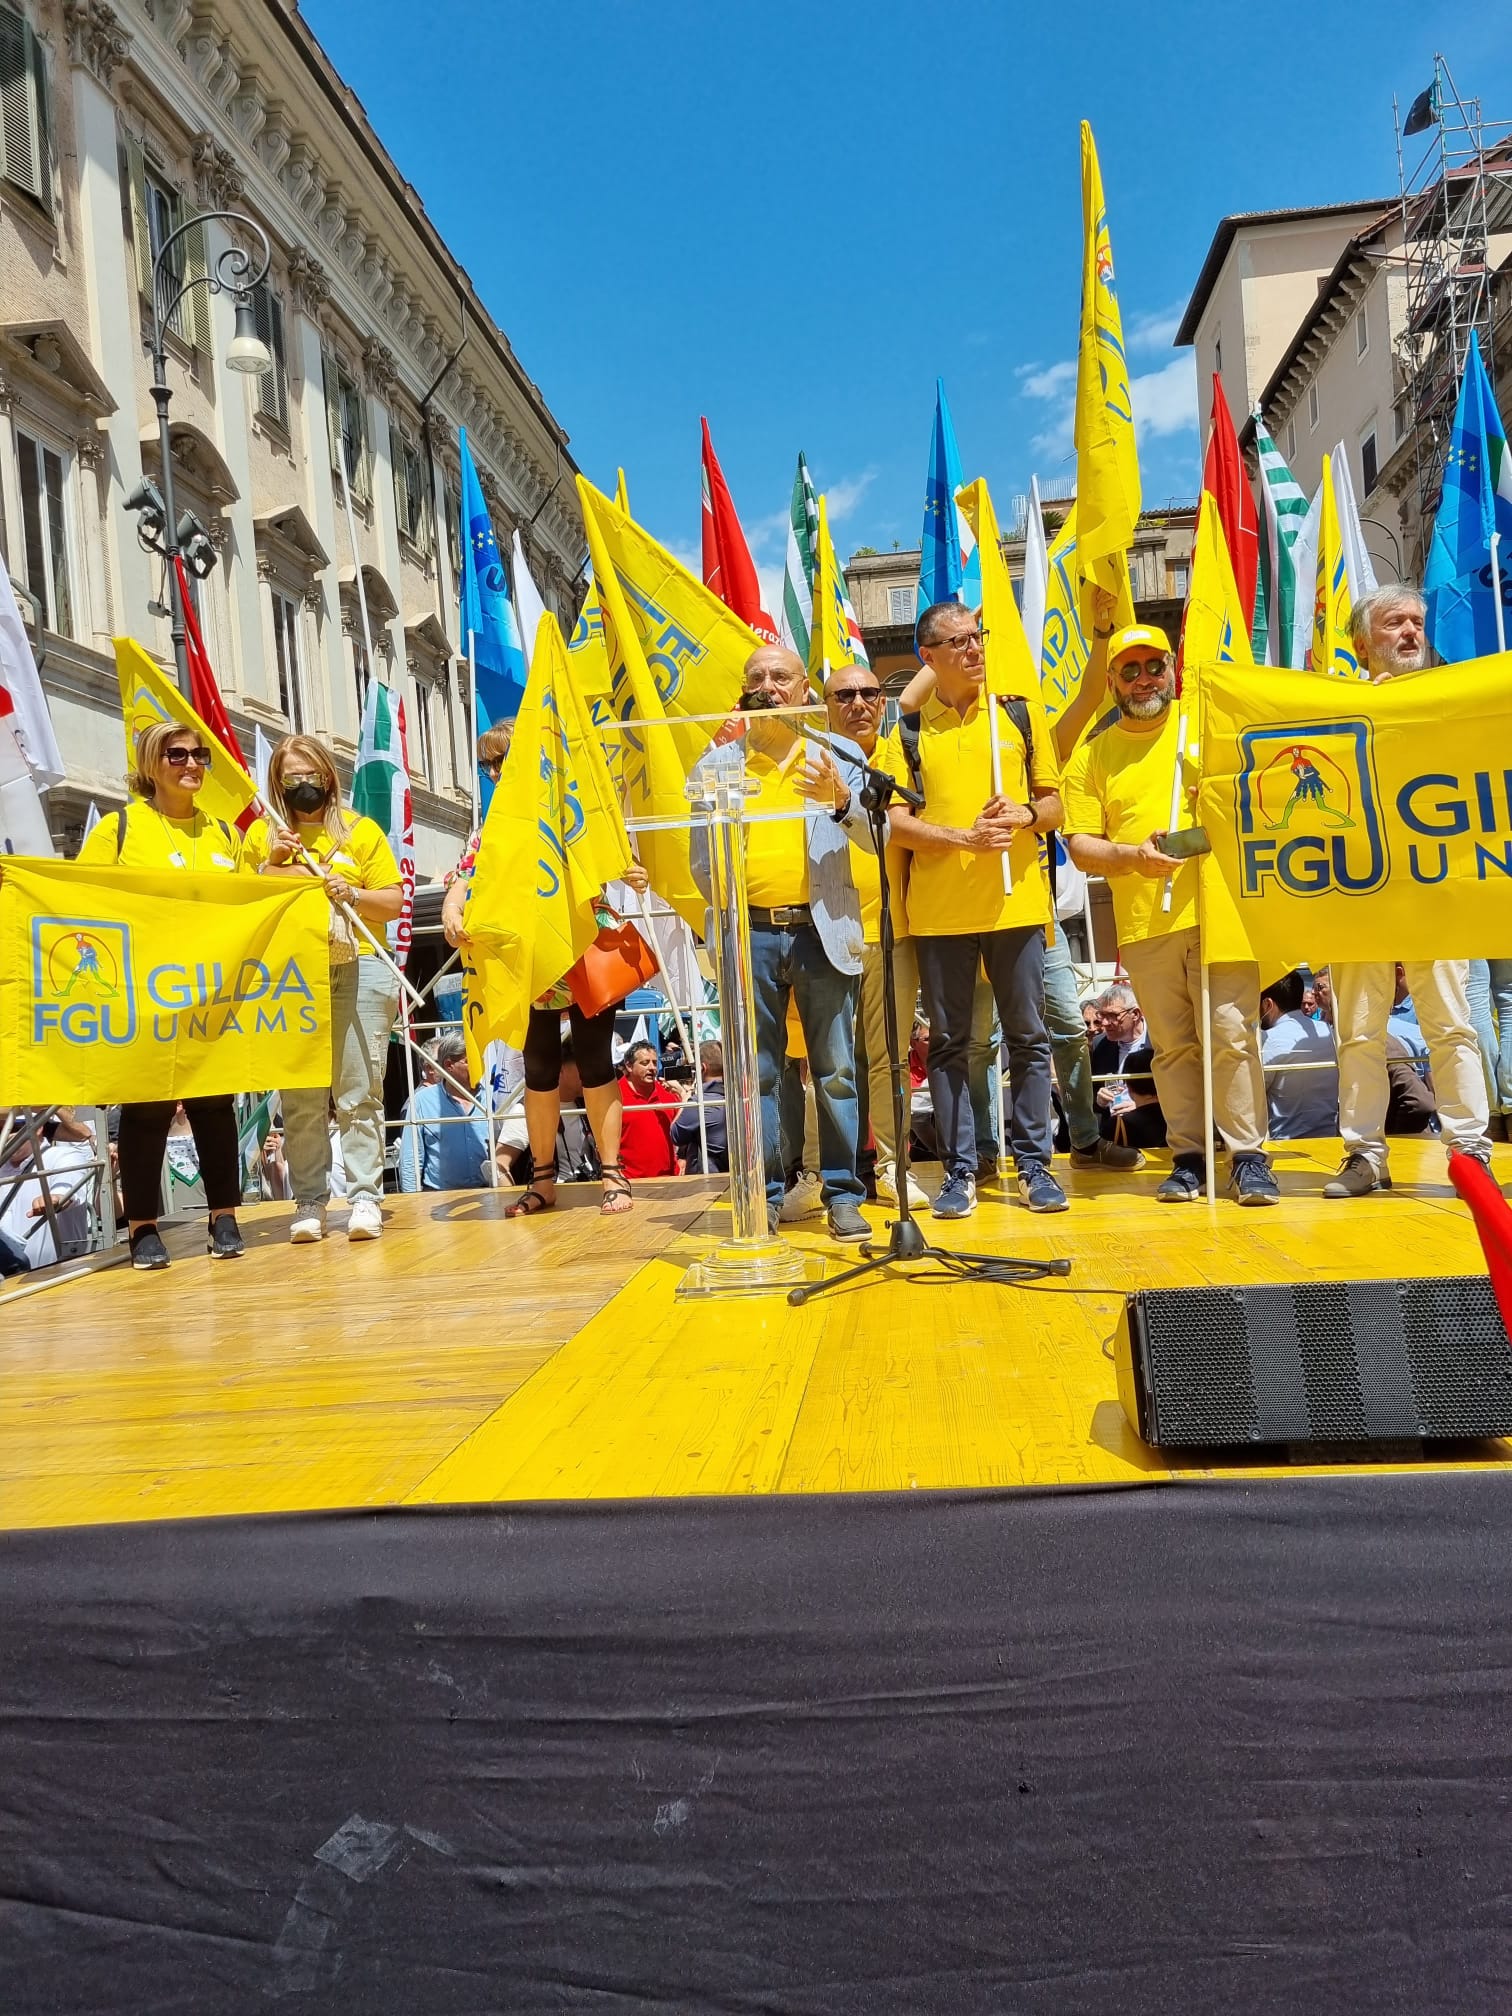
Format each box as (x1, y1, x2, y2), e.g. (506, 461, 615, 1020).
(825, 665, 929, 1210)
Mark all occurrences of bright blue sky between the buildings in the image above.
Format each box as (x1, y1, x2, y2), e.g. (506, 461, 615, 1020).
(304, 0, 1512, 596)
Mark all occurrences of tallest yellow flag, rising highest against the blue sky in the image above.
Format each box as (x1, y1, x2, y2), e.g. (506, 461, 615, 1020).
(1075, 119, 1139, 589)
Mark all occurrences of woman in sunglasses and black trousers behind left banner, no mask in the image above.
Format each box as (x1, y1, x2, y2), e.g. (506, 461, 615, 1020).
(79, 722, 246, 1268)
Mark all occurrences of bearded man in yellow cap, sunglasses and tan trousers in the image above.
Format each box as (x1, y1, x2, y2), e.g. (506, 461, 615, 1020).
(1064, 623, 1280, 1204)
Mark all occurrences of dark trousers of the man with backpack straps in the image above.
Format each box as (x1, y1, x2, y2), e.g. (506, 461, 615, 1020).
(913, 923, 1054, 1175)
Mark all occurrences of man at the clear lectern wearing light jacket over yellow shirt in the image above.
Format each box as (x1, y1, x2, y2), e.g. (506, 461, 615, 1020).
(691, 645, 873, 1240)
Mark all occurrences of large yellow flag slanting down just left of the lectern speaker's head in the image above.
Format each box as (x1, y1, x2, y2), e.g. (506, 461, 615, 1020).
(577, 476, 760, 931)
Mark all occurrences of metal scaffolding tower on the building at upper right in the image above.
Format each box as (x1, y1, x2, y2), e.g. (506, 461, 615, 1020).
(1391, 54, 1512, 569)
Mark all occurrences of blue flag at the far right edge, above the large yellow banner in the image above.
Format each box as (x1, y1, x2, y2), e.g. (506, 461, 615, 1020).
(1423, 331, 1512, 665)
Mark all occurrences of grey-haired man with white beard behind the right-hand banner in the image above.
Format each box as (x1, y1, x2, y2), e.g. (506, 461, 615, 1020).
(1322, 585, 1492, 1198)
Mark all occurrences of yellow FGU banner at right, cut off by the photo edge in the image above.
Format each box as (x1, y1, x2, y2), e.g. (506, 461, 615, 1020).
(1198, 653, 1512, 978)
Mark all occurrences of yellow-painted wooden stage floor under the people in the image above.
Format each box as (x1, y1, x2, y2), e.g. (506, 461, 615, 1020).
(0, 1141, 1512, 1528)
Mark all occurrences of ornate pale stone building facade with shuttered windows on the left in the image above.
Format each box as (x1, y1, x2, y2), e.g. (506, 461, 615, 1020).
(0, 0, 585, 877)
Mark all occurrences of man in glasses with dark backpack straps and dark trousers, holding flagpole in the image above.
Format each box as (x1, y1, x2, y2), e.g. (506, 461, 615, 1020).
(877, 603, 1066, 1218)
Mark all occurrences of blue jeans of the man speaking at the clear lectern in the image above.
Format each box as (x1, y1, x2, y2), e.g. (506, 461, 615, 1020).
(750, 923, 867, 1206)
